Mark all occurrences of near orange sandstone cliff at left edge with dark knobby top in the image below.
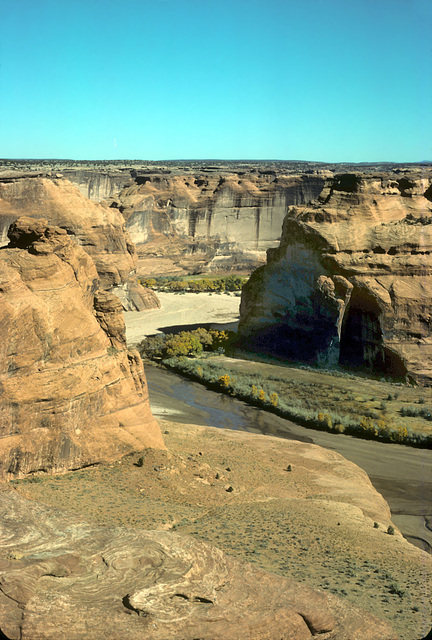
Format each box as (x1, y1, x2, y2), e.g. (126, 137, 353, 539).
(0, 218, 163, 477)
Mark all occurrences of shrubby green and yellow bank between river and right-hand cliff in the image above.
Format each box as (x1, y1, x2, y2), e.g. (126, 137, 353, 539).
(139, 328, 432, 447)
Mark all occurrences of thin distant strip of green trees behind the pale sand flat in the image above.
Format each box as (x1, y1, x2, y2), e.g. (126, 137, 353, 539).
(140, 275, 248, 293)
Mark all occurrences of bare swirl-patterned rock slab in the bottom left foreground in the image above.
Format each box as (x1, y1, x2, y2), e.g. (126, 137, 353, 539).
(0, 491, 396, 640)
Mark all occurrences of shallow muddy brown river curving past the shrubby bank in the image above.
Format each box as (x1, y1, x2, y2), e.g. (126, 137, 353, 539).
(146, 365, 432, 553)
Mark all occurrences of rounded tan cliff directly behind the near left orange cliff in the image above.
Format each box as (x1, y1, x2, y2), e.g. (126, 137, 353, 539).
(0, 175, 159, 310)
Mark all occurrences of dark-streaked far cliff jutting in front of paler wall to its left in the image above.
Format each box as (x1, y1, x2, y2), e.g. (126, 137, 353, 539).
(109, 172, 324, 269)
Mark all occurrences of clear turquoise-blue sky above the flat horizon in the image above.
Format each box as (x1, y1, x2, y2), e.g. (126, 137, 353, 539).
(0, 0, 432, 162)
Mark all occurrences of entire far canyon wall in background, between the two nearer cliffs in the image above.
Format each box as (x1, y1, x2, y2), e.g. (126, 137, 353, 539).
(63, 166, 326, 275)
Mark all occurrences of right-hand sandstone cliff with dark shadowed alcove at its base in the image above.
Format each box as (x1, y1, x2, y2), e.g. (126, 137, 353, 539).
(239, 174, 432, 384)
